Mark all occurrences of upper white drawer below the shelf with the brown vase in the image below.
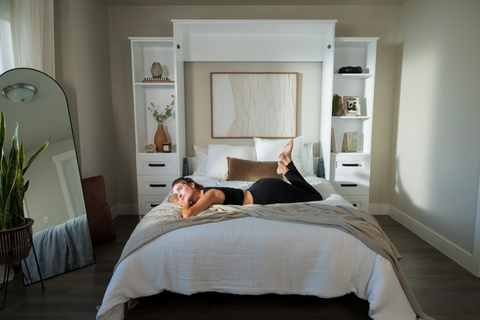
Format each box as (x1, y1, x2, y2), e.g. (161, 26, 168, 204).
(137, 153, 180, 178)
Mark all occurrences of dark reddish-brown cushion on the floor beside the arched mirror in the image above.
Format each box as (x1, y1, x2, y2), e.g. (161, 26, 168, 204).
(82, 176, 117, 244)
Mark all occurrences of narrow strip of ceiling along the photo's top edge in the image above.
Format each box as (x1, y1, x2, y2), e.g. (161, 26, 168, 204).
(103, 0, 406, 6)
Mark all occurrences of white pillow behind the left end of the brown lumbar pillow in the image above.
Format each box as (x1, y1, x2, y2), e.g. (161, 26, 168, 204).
(205, 144, 255, 180)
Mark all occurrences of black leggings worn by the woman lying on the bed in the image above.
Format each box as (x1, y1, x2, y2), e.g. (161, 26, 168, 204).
(248, 161, 323, 204)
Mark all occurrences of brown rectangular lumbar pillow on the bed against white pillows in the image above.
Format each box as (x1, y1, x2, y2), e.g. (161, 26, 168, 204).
(227, 157, 282, 181)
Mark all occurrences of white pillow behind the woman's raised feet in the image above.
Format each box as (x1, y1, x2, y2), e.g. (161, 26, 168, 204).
(253, 136, 304, 175)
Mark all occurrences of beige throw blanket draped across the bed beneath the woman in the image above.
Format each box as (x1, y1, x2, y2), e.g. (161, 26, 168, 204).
(117, 202, 433, 320)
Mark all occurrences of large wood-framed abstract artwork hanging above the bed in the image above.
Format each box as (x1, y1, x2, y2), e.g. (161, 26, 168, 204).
(210, 72, 298, 139)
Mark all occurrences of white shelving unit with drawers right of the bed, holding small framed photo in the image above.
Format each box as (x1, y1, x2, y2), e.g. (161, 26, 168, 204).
(330, 38, 378, 211)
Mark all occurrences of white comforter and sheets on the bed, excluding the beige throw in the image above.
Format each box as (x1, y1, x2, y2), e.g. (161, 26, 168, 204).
(97, 177, 426, 320)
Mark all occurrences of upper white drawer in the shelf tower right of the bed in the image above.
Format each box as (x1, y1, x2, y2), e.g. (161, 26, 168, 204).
(331, 153, 370, 175)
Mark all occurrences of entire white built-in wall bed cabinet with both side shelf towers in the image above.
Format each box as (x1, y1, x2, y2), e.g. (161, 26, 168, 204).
(130, 20, 377, 215)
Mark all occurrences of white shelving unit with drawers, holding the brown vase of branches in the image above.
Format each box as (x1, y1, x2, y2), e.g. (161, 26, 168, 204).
(129, 37, 185, 216)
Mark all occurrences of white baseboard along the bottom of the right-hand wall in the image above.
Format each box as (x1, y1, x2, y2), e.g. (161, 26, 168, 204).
(388, 205, 475, 274)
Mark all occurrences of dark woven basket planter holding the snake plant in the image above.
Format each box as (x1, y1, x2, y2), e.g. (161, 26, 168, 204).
(0, 218, 34, 265)
